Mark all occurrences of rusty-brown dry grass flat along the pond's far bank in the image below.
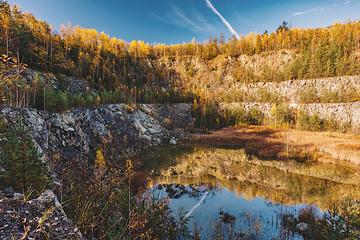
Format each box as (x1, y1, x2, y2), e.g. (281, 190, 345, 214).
(194, 126, 360, 165)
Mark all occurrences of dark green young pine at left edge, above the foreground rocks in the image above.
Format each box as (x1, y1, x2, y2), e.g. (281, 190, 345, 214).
(0, 116, 48, 192)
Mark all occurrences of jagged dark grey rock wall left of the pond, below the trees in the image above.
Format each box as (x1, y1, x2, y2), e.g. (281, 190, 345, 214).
(1, 104, 193, 168)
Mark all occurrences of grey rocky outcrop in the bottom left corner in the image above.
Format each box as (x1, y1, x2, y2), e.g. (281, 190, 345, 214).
(0, 190, 84, 240)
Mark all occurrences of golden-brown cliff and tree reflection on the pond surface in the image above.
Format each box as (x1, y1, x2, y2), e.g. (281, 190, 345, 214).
(144, 146, 360, 210)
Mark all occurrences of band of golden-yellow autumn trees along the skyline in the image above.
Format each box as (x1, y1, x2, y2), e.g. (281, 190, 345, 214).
(0, 0, 360, 87)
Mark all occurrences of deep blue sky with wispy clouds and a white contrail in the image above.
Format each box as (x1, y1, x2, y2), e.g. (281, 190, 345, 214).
(8, 0, 360, 45)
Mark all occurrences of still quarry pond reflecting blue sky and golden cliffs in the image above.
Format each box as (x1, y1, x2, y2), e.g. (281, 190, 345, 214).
(143, 145, 360, 239)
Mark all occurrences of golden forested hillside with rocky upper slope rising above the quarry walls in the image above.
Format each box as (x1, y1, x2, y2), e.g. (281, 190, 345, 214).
(0, 1, 360, 131)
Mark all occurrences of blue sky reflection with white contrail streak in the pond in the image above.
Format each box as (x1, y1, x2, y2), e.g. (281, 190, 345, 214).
(153, 179, 304, 239)
